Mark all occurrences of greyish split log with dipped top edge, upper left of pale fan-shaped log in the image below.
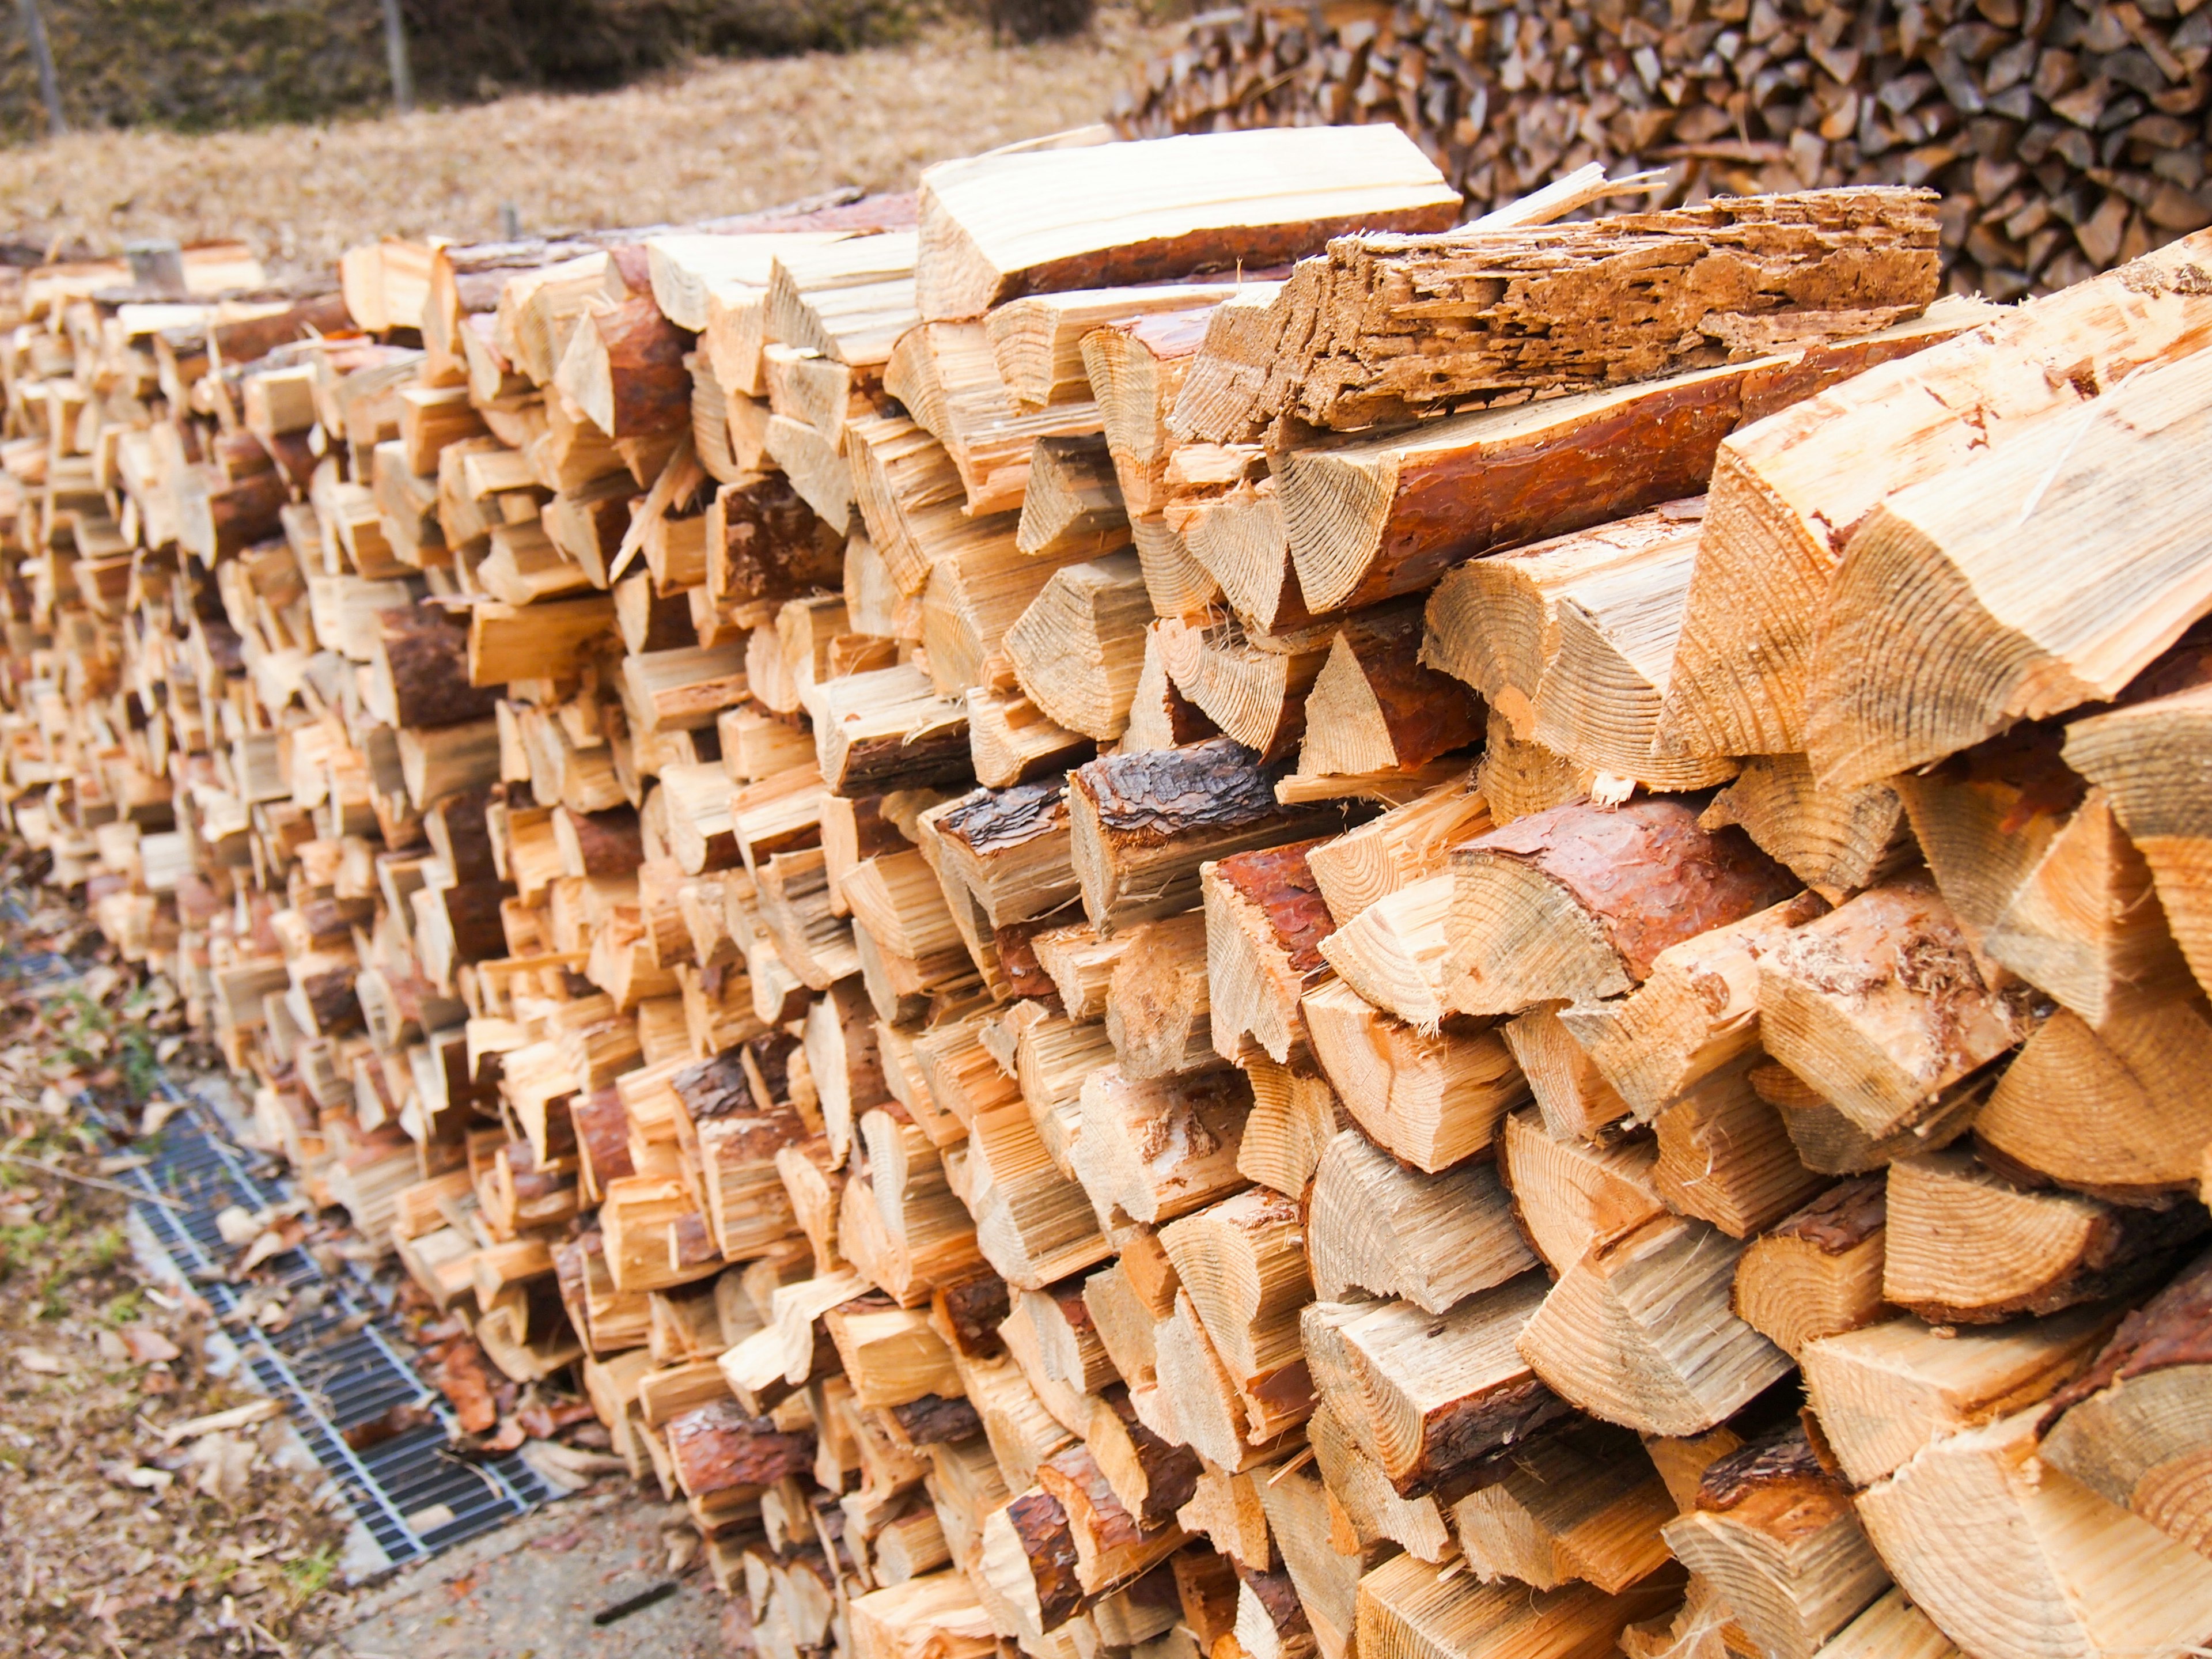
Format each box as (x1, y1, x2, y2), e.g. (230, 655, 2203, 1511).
(1305, 1130, 1535, 1314)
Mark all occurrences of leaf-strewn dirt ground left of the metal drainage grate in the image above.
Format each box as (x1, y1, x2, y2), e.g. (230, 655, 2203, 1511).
(0, 876, 343, 1659)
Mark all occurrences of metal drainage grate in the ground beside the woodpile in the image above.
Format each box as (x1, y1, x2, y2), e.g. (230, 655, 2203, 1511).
(126, 1080, 560, 1570)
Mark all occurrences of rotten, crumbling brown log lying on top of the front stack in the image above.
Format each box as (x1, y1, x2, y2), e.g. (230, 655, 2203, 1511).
(1177, 188, 1938, 442)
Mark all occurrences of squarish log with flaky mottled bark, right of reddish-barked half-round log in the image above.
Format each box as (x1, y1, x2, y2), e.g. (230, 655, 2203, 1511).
(1759, 876, 2026, 1137)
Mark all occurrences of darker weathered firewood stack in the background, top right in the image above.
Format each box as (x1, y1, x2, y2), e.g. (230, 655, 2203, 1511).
(1115, 0, 2212, 298)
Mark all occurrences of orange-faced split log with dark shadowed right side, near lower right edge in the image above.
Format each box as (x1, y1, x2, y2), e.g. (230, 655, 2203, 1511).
(1883, 1150, 2212, 1325)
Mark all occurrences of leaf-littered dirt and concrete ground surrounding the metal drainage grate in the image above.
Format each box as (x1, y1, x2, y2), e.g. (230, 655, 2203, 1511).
(0, 861, 728, 1659)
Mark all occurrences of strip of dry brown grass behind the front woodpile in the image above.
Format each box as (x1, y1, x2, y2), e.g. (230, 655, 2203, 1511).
(0, 9, 1172, 285)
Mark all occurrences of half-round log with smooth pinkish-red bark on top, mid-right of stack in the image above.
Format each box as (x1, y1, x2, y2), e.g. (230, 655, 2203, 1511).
(1449, 801, 1794, 1013)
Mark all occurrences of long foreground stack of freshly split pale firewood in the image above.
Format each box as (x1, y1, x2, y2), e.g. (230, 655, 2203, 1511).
(0, 124, 2212, 1659)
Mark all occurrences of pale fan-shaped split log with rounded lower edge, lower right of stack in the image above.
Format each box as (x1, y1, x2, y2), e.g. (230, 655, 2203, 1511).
(1520, 1217, 1790, 1435)
